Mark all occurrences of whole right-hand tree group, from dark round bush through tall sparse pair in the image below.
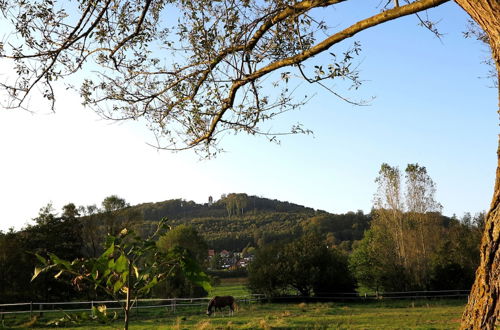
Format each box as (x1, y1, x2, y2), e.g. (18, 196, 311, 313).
(249, 164, 485, 296)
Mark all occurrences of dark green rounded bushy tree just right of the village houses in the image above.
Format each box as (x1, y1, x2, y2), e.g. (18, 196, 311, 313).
(248, 233, 354, 296)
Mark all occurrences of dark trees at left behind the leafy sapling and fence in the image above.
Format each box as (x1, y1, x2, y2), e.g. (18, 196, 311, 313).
(0, 196, 207, 303)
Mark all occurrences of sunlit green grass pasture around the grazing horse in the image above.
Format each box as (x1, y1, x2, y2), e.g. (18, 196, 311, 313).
(0, 279, 465, 330)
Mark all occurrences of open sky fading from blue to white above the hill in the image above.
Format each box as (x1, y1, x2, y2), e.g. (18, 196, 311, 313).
(0, 1, 498, 231)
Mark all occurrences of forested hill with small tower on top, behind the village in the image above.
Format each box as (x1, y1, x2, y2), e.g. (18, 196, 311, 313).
(120, 194, 370, 251)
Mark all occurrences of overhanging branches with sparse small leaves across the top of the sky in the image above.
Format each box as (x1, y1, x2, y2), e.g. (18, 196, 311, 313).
(0, 0, 454, 156)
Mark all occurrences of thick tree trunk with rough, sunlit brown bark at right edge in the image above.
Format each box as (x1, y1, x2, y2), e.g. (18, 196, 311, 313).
(455, 0, 500, 330)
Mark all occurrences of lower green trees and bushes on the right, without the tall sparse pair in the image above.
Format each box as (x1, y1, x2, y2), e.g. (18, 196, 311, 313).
(248, 213, 484, 296)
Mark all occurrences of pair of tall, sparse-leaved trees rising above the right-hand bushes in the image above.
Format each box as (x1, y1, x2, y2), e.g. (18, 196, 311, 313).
(371, 163, 444, 290)
